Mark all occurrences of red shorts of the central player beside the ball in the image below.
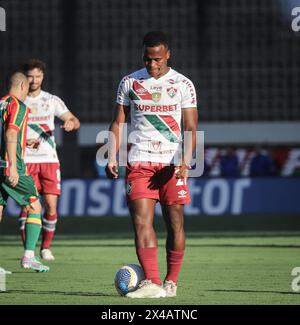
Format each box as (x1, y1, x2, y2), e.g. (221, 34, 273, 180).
(126, 162, 191, 205)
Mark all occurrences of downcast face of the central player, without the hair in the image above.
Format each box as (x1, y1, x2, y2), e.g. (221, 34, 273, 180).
(143, 45, 170, 79)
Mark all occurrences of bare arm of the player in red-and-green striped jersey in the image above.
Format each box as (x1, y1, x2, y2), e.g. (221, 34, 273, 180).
(5, 128, 19, 187)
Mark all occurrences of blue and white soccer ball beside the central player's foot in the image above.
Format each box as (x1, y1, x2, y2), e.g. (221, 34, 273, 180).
(115, 264, 145, 296)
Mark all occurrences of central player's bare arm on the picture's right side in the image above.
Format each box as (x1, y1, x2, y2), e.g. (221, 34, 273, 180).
(176, 108, 198, 178)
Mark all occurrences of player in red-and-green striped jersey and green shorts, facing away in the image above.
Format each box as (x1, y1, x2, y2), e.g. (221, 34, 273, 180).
(0, 72, 49, 272)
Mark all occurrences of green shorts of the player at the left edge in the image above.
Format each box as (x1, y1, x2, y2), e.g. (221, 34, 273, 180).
(0, 176, 39, 206)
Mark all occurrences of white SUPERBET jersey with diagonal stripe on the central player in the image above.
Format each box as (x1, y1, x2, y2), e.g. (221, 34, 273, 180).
(117, 68, 197, 163)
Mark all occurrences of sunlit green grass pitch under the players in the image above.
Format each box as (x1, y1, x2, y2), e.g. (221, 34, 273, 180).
(0, 232, 300, 305)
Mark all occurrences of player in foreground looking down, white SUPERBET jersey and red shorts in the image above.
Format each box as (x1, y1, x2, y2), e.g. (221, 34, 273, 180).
(106, 31, 198, 298)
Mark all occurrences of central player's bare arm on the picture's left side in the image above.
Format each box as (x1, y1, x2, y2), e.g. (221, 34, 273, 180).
(105, 104, 129, 178)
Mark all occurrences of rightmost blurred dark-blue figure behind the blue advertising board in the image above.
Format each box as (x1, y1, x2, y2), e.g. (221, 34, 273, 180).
(250, 148, 276, 177)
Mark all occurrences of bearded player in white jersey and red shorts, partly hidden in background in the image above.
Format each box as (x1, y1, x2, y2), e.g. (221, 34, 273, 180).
(19, 59, 80, 261)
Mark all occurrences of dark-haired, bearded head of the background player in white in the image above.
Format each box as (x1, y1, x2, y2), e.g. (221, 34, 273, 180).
(23, 59, 46, 92)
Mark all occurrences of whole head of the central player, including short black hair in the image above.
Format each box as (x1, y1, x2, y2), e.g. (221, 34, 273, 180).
(143, 31, 170, 79)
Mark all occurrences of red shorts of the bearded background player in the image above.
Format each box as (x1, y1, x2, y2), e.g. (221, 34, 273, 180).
(26, 163, 61, 195)
